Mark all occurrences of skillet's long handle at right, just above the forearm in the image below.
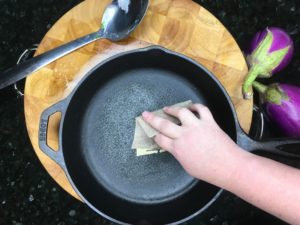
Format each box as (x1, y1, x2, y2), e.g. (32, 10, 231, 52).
(238, 131, 300, 160)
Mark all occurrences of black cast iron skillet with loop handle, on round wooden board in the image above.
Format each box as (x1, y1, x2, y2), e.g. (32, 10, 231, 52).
(39, 46, 300, 225)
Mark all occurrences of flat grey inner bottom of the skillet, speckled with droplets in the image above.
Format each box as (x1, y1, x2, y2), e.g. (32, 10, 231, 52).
(81, 68, 202, 201)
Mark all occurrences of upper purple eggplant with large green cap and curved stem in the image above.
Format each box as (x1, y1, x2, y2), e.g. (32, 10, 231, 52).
(242, 27, 294, 99)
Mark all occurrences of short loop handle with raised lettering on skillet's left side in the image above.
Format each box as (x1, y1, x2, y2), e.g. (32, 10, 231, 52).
(39, 101, 65, 168)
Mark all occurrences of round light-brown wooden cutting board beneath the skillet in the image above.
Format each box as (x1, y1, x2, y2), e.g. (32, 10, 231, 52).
(24, 0, 253, 199)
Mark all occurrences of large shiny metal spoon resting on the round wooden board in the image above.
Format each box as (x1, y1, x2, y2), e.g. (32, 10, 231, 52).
(0, 0, 149, 89)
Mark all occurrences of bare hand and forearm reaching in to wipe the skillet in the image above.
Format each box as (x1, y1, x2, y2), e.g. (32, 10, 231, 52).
(143, 104, 300, 224)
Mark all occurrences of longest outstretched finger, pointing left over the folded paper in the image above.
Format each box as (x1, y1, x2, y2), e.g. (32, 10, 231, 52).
(142, 112, 181, 138)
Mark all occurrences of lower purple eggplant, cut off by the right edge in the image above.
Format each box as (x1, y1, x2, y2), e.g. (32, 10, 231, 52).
(253, 81, 300, 138)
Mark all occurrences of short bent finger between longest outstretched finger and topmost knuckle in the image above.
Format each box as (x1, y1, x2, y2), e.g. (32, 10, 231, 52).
(164, 107, 197, 125)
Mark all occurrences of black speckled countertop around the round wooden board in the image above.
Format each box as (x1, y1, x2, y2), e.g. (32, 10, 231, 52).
(0, 0, 300, 225)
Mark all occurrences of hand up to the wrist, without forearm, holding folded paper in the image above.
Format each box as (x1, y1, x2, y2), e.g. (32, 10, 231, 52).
(142, 104, 244, 187)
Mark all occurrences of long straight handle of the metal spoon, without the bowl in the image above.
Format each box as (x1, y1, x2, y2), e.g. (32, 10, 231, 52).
(0, 30, 103, 89)
